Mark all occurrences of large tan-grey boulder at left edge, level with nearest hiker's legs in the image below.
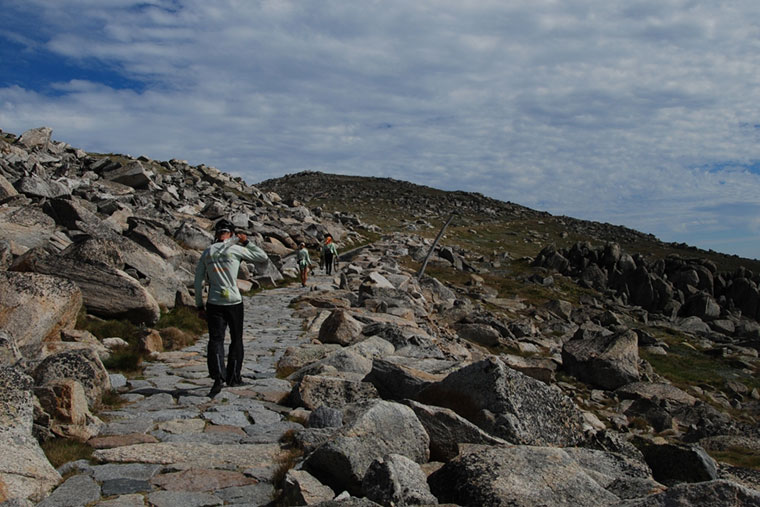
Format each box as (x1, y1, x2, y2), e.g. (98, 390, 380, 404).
(0, 271, 82, 358)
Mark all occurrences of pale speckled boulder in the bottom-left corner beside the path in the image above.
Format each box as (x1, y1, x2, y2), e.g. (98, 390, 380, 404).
(0, 366, 61, 502)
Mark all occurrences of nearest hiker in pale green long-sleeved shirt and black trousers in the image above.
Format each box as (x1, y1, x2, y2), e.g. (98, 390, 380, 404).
(195, 219, 268, 398)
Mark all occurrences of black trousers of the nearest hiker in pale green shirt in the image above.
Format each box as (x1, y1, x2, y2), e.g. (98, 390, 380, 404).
(206, 302, 243, 382)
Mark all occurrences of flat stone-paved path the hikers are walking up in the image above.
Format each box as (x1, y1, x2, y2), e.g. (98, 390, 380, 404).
(38, 275, 330, 507)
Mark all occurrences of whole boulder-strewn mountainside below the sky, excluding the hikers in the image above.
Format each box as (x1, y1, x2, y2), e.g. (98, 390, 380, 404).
(0, 128, 760, 506)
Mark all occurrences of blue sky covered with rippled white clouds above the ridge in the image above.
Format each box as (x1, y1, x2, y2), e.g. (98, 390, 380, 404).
(0, 0, 760, 258)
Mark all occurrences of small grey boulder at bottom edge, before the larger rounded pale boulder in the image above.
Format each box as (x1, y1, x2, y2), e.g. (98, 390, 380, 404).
(362, 454, 438, 506)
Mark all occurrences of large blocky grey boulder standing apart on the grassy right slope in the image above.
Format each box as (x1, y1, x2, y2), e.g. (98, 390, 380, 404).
(562, 330, 639, 389)
